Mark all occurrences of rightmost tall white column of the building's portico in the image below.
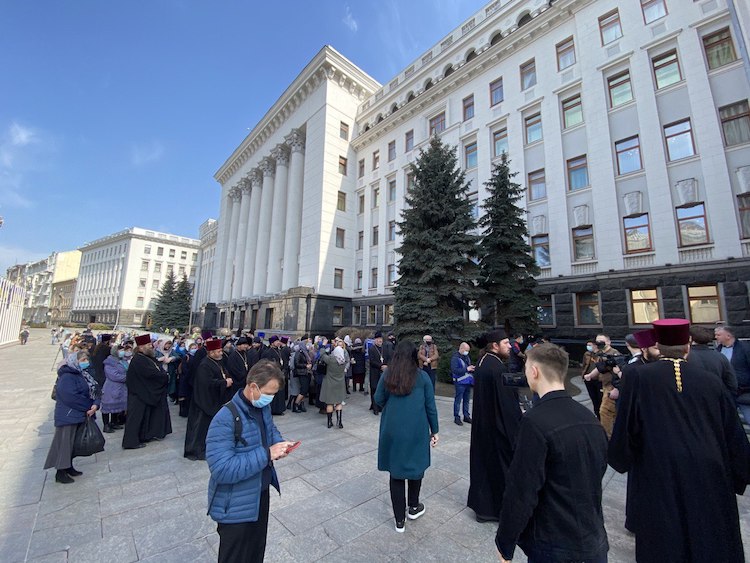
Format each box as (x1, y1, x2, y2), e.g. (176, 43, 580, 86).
(281, 129, 305, 290)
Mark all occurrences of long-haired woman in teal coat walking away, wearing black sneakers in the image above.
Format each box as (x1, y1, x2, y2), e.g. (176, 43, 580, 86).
(375, 341, 438, 533)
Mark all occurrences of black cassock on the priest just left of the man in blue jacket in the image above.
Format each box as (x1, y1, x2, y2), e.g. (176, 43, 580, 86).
(184, 357, 232, 459)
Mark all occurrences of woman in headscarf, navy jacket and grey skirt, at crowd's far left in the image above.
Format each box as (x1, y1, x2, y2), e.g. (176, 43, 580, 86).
(44, 349, 100, 483)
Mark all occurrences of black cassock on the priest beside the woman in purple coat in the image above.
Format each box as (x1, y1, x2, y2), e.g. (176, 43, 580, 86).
(122, 352, 172, 448)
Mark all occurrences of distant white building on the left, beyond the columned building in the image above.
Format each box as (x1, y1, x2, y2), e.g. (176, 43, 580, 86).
(71, 227, 200, 327)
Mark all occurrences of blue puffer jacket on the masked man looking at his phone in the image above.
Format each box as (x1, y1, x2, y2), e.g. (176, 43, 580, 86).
(206, 390, 283, 524)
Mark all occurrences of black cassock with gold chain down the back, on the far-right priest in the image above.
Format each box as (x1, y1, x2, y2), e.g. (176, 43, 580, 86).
(609, 359, 750, 563)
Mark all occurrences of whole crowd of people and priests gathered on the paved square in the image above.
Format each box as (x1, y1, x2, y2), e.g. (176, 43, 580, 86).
(45, 319, 750, 562)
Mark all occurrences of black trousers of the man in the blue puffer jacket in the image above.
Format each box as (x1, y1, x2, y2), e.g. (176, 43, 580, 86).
(216, 489, 269, 563)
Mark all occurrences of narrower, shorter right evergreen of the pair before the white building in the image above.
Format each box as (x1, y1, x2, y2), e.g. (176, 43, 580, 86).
(479, 153, 539, 332)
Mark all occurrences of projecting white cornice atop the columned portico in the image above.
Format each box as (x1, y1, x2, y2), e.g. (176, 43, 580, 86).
(214, 45, 380, 186)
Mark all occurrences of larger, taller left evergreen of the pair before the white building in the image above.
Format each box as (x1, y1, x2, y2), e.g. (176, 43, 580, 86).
(394, 136, 481, 351)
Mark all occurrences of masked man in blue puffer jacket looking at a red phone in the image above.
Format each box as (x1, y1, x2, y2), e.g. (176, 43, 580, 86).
(206, 360, 294, 563)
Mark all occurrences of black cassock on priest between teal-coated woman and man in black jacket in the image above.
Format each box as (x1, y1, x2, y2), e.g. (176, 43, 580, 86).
(467, 352, 522, 520)
